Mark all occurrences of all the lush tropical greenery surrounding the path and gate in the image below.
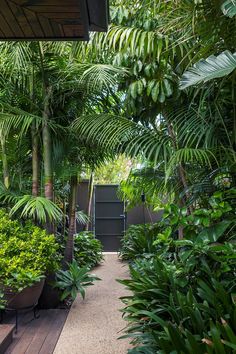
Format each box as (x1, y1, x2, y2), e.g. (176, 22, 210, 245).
(0, 0, 236, 354)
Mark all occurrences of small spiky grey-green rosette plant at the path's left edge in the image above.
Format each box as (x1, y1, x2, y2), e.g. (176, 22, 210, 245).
(55, 260, 100, 300)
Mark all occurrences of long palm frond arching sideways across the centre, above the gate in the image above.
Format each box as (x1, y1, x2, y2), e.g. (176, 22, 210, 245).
(72, 114, 171, 163)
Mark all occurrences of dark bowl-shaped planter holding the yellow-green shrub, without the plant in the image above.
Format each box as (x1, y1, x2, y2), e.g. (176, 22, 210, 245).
(3, 279, 45, 310)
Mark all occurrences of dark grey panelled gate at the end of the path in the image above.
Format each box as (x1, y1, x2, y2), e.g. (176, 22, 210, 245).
(94, 185, 125, 251)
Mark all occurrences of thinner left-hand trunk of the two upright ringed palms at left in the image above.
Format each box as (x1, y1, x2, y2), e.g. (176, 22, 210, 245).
(32, 123, 39, 197)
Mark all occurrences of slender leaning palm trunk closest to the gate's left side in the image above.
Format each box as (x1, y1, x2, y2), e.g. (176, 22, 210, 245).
(64, 176, 78, 264)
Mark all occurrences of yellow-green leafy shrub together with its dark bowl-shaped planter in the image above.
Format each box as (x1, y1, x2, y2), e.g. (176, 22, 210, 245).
(0, 210, 59, 309)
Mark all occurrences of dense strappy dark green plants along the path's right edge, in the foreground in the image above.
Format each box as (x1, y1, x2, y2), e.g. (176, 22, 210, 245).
(121, 245, 236, 354)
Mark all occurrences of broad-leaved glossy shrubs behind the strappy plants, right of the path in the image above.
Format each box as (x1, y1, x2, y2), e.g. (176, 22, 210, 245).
(120, 189, 236, 264)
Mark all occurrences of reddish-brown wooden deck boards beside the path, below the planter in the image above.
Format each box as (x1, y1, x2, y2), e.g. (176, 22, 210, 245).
(3, 309, 68, 354)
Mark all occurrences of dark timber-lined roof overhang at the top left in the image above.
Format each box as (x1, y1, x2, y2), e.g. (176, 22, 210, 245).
(0, 0, 108, 40)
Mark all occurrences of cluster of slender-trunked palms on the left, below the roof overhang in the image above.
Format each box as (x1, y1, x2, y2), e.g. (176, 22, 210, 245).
(0, 43, 123, 262)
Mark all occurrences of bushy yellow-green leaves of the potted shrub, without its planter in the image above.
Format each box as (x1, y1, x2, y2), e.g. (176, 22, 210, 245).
(0, 210, 59, 290)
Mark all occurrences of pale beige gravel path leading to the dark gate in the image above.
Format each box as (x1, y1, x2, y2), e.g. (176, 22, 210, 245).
(54, 254, 129, 354)
